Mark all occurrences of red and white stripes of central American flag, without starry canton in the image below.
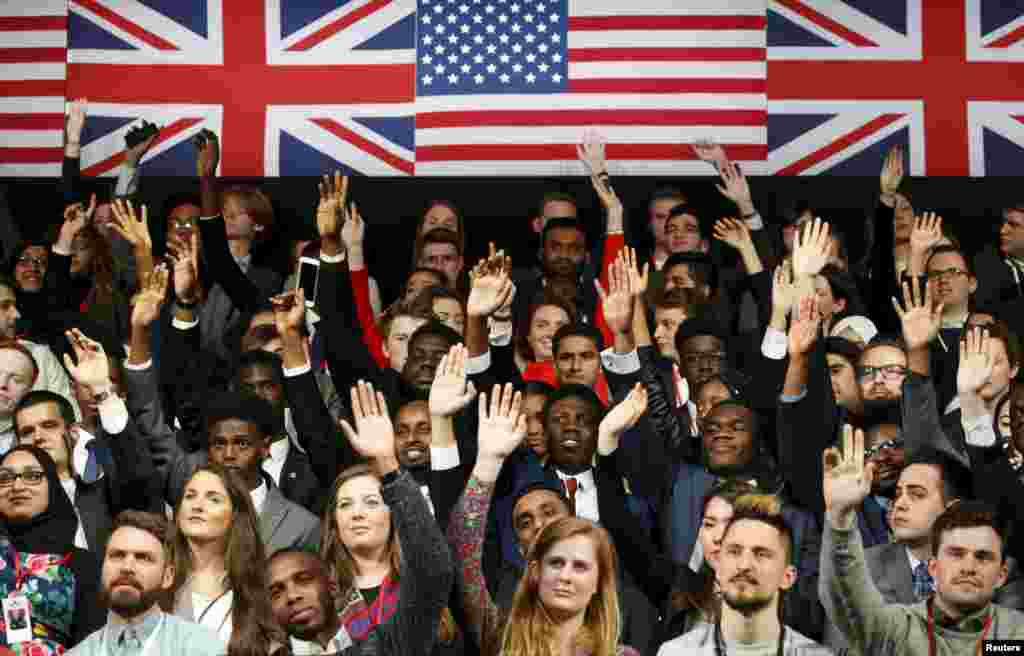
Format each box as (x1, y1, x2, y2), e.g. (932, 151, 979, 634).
(416, 0, 767, 176)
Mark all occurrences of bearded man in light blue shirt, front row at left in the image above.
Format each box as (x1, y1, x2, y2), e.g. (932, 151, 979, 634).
(68, 512, 224, 656)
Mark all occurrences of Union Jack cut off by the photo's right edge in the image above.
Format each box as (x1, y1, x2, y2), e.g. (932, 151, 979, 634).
(763, 0, 1024, 176)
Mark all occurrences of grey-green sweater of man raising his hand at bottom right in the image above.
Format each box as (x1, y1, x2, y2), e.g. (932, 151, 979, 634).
(821, 517, 1024, 656)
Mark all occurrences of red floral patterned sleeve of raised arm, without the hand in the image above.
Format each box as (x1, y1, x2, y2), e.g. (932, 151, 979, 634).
(447, 476, 498, 645)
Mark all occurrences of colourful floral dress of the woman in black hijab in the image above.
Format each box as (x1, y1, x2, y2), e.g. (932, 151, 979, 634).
(0, 537, 76, 656)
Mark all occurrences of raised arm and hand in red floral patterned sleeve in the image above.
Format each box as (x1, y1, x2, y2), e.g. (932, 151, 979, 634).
(447, 385, 526, 648)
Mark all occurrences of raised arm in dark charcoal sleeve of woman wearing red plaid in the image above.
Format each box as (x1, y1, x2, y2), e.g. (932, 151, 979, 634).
(342, 383, 455, 656)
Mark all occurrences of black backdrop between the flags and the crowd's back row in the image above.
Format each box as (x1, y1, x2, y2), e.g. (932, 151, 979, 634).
(0, 176, 1007, 302)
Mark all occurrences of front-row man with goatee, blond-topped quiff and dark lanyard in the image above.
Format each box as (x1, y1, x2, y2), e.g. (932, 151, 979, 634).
(657, 494, 831, 656)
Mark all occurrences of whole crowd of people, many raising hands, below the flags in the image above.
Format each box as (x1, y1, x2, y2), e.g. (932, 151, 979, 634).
(0, 101, 1024, 656)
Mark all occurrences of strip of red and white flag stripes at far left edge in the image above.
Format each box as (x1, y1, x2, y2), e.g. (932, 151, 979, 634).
(0, 0, 68, 177)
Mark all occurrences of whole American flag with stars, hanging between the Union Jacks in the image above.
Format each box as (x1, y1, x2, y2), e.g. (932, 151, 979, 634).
(416, 0, 767, 175)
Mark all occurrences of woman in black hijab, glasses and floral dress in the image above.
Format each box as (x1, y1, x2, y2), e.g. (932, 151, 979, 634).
(0, 446, 106, 656)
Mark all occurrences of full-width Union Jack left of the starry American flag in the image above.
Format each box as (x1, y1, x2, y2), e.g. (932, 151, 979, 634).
(68, 0, 416, 177)
